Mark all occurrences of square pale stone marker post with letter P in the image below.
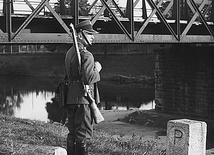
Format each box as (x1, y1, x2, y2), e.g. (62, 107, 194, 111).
(166, 119, 207, 155)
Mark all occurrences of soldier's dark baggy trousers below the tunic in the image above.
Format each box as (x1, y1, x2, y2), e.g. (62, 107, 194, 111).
(67, 104, 93, 155)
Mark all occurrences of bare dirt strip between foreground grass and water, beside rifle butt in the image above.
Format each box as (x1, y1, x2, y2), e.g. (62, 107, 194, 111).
(94, 110, 166, 147)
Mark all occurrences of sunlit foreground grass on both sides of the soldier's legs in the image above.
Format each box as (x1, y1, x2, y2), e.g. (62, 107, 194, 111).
(0, 115, 164, 155)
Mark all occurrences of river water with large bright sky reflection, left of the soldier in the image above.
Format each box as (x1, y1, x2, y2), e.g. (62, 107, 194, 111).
(0, 78, 55, 122)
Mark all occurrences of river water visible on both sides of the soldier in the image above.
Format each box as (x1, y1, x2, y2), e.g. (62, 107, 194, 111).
(0, 78, 155, 123)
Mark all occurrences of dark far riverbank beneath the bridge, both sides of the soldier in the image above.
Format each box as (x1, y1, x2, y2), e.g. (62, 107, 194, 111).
(0, 53, 155, 83)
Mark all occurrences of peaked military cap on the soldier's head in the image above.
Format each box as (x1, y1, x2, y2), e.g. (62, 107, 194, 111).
(75, 20, 98, 34)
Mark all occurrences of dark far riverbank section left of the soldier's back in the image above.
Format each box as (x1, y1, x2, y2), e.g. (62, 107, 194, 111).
(0, 53, 64, 77)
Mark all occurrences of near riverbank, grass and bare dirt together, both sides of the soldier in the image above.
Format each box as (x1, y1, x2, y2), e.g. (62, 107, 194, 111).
(0, 110, 214, 155)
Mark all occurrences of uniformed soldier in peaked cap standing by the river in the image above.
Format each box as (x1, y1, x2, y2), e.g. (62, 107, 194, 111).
(65, 20, 102, 155)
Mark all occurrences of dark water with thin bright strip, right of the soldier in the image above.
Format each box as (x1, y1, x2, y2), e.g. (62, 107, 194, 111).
(98, 81, 155, 110)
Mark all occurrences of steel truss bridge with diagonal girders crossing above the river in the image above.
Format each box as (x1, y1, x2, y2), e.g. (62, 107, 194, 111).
(0, 0, 214, 43)
